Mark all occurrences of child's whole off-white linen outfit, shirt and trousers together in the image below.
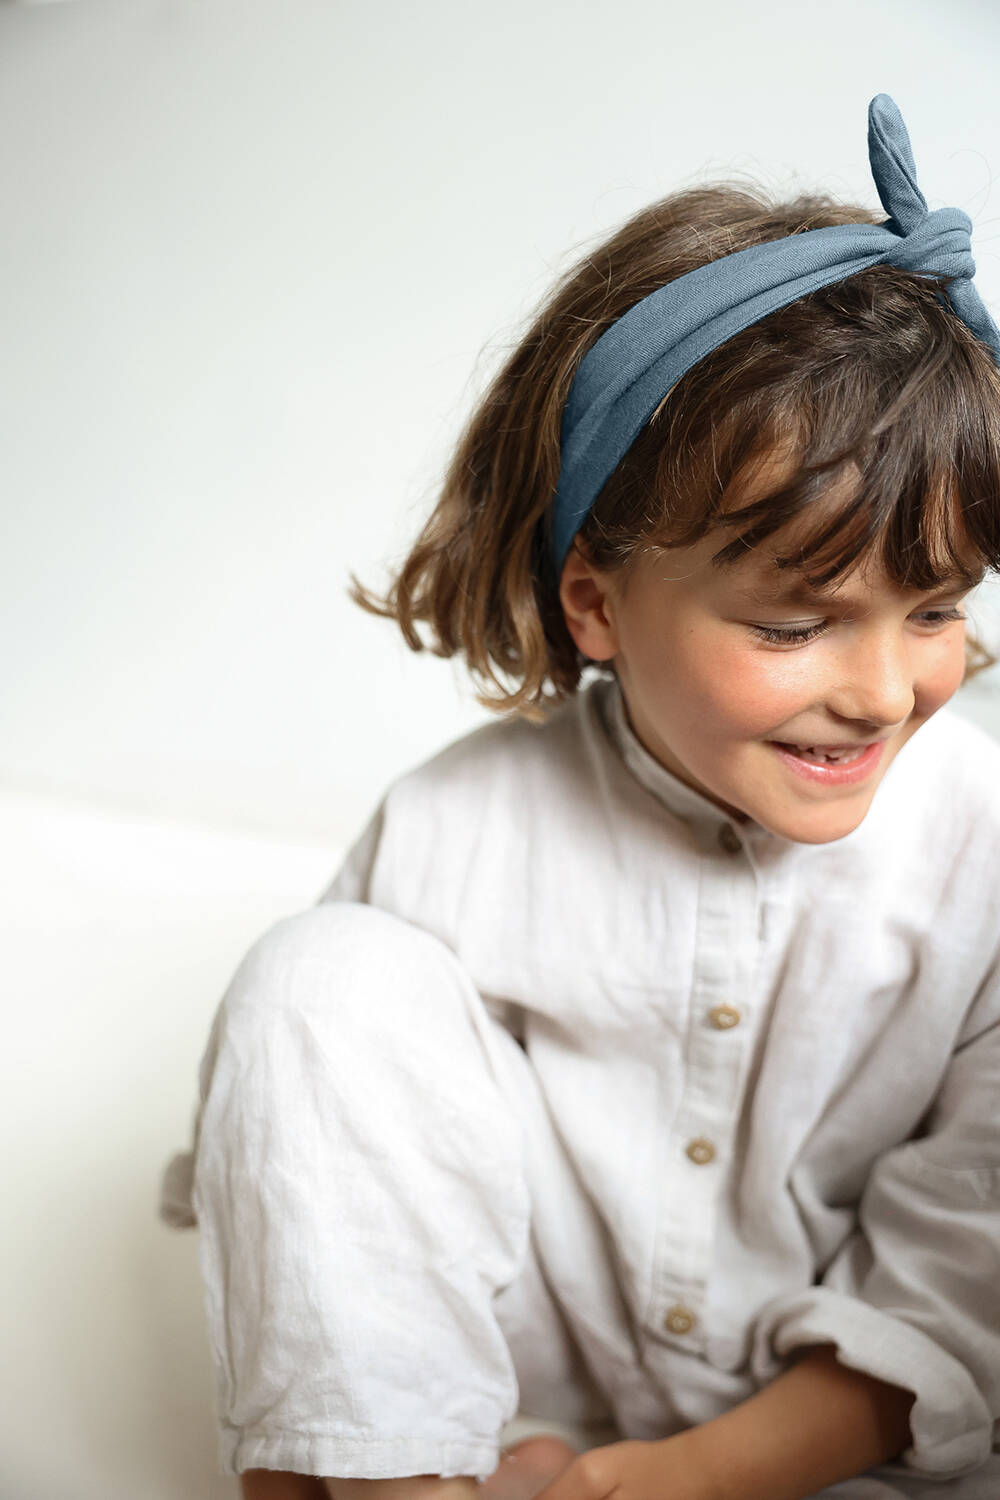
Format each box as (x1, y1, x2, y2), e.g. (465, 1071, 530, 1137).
(160, 678, 1000, 1500)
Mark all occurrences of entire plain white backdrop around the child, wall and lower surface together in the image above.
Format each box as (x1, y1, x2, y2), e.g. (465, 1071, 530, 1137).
(0, 0, 1000, 1500)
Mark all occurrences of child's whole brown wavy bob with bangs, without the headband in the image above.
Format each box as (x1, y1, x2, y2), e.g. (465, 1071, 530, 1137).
(348, 182, 1000, 722)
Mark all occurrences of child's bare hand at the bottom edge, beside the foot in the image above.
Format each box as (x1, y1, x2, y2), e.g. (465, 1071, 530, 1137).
(535, 1433, 718, 1500)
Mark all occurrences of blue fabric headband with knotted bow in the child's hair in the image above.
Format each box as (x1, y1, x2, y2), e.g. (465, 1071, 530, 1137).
(552, 93, 1000, 579)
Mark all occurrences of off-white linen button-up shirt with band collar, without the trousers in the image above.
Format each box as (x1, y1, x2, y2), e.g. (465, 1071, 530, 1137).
(322, 678, 1000, 1497)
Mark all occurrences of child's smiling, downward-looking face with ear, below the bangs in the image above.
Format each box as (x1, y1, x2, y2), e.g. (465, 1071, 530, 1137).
(562, 516, 969, 843)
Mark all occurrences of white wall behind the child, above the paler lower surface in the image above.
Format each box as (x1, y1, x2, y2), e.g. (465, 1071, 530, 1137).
(0, 0, 1000, 840)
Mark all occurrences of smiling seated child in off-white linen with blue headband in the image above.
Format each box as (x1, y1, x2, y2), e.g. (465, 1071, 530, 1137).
(162, 95, 1000, 1500)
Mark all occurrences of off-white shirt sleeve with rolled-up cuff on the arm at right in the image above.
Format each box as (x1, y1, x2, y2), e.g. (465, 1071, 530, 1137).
(751, 971, 1000, 1479)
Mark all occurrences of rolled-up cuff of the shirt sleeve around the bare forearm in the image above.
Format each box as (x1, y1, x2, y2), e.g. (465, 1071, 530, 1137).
(751, 1287, 993, 1479)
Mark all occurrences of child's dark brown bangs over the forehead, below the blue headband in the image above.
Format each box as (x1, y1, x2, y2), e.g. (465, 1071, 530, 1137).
(706, 286, 1000, 591)
